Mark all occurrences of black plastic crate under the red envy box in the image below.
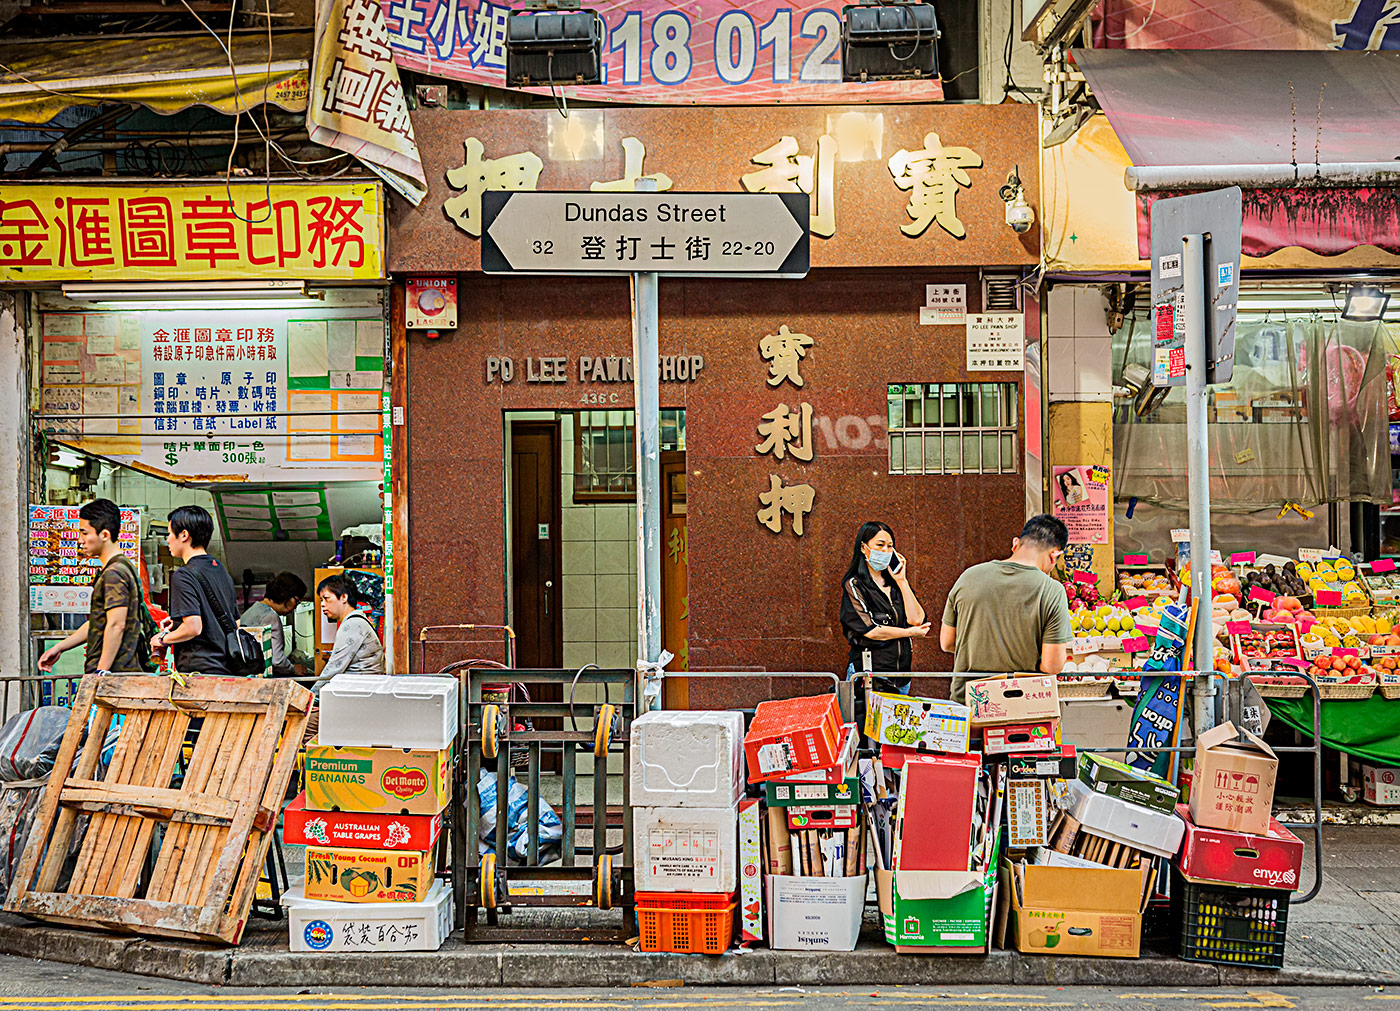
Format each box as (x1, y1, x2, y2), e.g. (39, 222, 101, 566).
(1172, 867, 1292, 969)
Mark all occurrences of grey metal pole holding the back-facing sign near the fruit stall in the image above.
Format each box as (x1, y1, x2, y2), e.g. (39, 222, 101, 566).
(1182, 235, 1215, 734)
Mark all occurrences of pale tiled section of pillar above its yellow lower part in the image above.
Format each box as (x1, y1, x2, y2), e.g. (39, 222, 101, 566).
(1046, 284, 1113, 400)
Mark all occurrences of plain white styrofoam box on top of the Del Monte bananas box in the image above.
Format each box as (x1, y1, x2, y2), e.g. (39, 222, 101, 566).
(318, 674, 456, 751)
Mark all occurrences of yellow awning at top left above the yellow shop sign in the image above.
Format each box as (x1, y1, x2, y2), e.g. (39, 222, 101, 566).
(0, 29, 312, 123)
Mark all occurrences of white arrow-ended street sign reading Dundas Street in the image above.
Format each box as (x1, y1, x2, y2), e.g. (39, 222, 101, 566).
(482, 190, 811, 277)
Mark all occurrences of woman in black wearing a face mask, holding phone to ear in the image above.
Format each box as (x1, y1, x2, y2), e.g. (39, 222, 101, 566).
(841, 520, 928, 695)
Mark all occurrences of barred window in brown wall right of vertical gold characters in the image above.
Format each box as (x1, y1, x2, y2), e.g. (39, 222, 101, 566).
(889, 382, 1021, 473)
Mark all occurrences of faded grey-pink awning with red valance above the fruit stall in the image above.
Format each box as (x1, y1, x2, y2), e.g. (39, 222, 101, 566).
(1072, 49, 1400, 256)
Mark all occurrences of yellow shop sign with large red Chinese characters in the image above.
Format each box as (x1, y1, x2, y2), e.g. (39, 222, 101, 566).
(0, 182, 384, 283)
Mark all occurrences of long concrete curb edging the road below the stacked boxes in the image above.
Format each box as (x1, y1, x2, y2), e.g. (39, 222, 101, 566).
(0, 914, 1400, 990)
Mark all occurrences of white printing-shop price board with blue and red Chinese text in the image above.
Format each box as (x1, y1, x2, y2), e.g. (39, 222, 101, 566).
(41, 309, 384, 482)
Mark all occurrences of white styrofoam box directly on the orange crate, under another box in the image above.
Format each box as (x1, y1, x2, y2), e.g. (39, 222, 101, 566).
(631, 807, 739, 892)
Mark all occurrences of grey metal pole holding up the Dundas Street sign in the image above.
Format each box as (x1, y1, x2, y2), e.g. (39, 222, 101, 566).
(631, 179, 661, 677)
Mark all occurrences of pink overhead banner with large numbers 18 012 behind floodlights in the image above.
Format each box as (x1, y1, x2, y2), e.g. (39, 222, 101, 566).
(382, 0, 944, 105)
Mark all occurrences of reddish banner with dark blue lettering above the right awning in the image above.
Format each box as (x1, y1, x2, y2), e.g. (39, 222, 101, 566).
(1093, 0, 1400, 49)
